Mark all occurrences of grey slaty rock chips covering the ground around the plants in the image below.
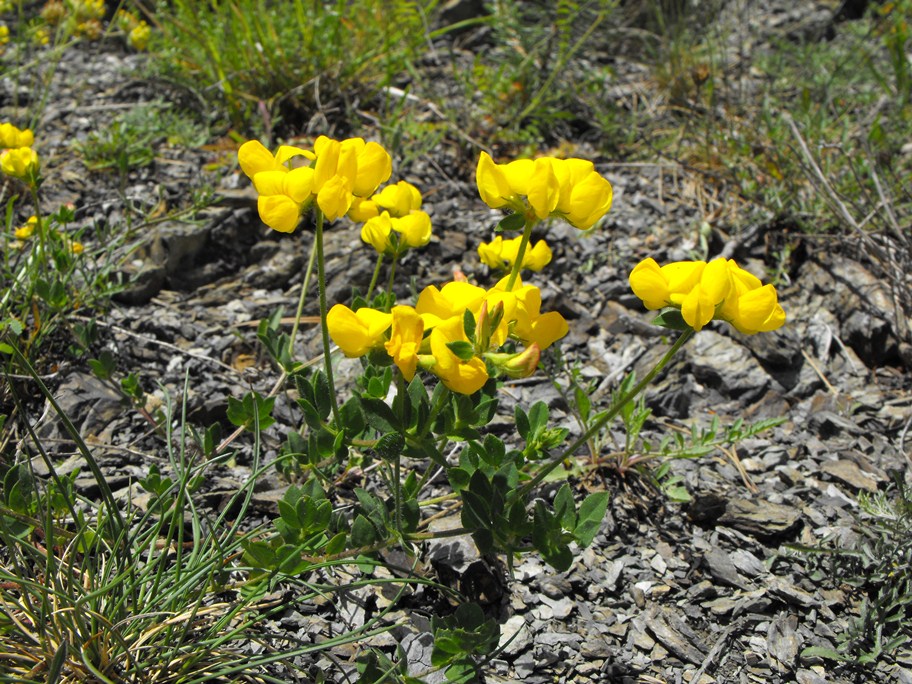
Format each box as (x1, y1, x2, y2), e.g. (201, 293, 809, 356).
(6, 2, 912, 684)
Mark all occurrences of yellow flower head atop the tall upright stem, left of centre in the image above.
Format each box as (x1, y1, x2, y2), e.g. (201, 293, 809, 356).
(238, 136, 393, 233)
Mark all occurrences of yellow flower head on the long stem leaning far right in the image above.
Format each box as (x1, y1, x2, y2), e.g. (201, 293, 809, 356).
(630, 258, 785, 335)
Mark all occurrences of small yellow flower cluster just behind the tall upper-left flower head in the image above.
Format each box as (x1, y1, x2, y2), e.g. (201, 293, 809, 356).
(348, 181, 431, 254)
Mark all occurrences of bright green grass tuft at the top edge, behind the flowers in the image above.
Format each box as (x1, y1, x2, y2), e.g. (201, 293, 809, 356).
(144, 0, 436, 134)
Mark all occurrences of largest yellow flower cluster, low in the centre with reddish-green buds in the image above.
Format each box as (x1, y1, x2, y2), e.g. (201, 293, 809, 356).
(326, 278, 568, 394)
